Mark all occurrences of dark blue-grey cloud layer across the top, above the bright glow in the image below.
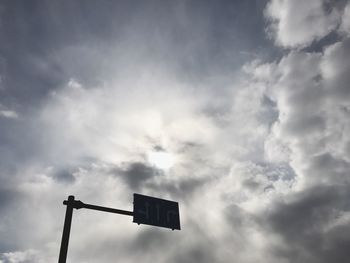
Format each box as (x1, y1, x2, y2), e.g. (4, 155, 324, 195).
(0, 1, 274, 107)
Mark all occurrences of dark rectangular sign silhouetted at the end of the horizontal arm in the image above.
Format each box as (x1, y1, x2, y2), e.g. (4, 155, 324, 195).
(133, 194, 180, 230)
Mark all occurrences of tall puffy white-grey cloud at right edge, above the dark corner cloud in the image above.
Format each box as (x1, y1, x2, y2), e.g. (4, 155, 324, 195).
(249, 40, 350, 189)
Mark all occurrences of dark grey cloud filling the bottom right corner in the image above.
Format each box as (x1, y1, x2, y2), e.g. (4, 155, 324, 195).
(261, 185, 350, 263)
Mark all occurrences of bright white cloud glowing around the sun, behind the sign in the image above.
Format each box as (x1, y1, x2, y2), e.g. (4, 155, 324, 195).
(12, 46, 282, 262)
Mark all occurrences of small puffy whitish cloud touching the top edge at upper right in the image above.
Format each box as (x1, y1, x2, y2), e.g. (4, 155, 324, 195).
(265, 0, 341, 48)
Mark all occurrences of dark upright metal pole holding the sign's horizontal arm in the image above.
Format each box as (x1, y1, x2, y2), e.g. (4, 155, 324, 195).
(58, 195, 74, 263)
